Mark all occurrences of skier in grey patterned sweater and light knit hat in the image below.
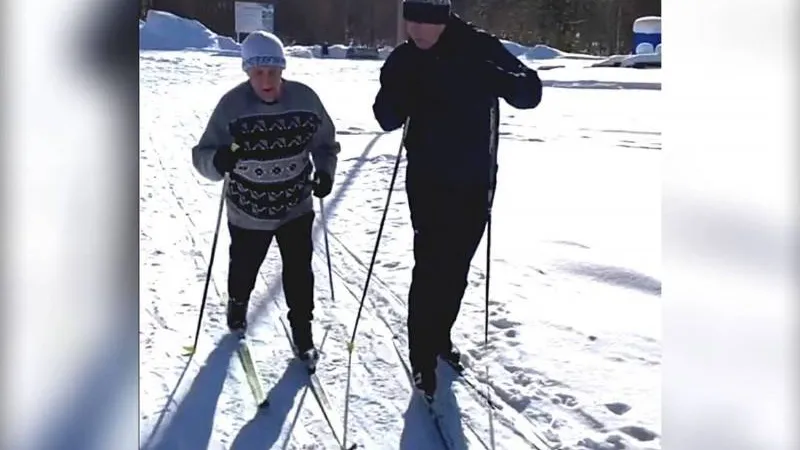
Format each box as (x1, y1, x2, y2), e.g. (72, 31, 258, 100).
(192, 31, 340, 358)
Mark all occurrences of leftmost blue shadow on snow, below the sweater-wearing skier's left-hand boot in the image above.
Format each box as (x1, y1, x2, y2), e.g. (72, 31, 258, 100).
(147, 334, 239, 450)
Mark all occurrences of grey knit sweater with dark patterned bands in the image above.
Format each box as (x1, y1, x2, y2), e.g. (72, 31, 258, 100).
(192, 80, 340, 230)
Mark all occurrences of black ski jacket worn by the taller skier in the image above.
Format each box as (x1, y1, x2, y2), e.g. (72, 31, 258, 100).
(373, 14, 542, 190)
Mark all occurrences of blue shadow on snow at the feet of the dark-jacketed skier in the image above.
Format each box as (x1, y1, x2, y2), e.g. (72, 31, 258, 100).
(400, 364, 467, 450)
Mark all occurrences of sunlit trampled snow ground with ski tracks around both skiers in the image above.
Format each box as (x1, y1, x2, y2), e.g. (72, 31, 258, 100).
(140, 52, 661, 450)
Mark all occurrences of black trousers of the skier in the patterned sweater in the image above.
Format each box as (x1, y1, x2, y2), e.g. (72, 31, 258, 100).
(228, 211, 314, 327)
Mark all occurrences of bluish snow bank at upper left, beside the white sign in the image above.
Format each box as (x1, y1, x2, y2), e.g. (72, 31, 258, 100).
(139, 10, 239, 51)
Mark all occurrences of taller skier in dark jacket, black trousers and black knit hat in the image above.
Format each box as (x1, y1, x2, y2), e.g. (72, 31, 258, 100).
(373, 0, 542, 397)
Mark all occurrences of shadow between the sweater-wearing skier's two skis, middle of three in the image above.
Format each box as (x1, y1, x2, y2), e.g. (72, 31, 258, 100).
(231, 359, 306, 450)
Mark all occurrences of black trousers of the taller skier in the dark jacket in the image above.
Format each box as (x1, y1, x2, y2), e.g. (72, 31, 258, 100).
(407, 184, 488, 370)
